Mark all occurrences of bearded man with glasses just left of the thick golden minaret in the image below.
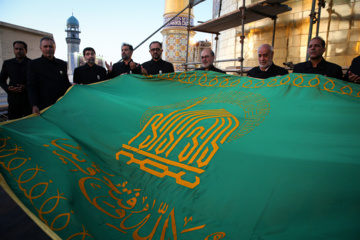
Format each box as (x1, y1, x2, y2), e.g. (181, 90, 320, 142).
(141, 41, 174, 75)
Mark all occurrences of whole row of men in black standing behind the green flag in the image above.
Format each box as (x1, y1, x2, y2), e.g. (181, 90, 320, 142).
(0, 37, 360, 120)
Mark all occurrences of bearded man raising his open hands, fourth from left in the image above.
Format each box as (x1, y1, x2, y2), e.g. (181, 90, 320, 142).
(105, 43, 141, 78)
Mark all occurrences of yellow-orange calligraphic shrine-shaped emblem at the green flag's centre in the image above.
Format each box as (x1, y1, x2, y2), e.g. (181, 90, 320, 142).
(116, 92, 270, 188)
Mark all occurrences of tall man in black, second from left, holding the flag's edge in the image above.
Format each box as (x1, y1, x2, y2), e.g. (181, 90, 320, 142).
(27, 37, 71, 115)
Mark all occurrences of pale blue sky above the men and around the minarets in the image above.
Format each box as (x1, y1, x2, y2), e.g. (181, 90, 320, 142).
(0, 0, 213, 63)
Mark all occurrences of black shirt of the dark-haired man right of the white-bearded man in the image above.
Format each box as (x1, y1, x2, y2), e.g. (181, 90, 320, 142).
(293, 58, 343, 80)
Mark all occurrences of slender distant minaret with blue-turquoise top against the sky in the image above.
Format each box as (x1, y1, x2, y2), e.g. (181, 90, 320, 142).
(65, 14, 81, 77)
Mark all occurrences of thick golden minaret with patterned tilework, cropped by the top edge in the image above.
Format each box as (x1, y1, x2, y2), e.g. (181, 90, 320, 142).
(161, 0, 195, 71)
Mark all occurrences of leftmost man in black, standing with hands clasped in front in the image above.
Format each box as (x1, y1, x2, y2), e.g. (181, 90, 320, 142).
(0, 41, 31, 120)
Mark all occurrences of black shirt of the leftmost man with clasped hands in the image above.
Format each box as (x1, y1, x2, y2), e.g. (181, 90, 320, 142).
(0, 57, 31, 105)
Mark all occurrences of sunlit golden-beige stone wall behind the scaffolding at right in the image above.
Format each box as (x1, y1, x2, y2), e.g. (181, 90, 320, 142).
(214, 0, 360, 71)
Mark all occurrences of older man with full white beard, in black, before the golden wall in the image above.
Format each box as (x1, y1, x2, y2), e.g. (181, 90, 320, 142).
(247, 44, 289, 79)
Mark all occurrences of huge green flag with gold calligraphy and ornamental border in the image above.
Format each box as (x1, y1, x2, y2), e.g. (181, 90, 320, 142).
(0, 71, 360, 240)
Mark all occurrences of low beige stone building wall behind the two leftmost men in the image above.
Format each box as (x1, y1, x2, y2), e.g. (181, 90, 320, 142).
(0, 22, 53, 66)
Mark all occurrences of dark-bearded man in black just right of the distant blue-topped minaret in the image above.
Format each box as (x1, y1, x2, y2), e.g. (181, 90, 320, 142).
(74, 47, 107, 84)
